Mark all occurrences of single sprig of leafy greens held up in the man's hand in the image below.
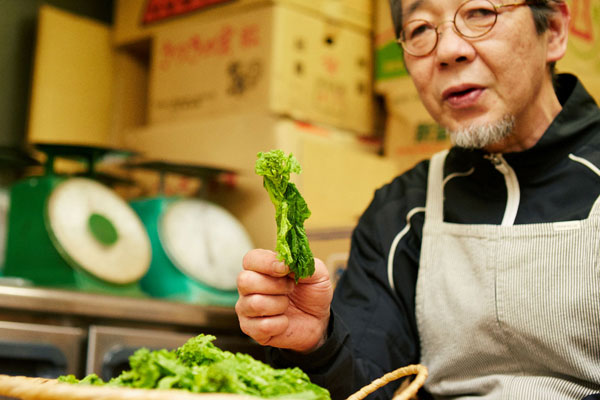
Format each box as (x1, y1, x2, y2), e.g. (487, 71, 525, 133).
(254, 150, 315, 282)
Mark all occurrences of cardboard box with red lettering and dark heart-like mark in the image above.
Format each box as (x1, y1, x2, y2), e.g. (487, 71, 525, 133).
(149, 4, 373, 135)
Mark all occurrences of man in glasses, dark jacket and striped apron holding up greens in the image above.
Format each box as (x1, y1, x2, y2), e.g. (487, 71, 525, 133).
(236, 0, 600, 399)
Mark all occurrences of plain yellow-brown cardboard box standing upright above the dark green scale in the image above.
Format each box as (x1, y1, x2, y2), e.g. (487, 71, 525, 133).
(27, 5, 114, 147)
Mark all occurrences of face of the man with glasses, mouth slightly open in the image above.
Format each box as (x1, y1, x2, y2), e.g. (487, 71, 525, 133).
(402, 0, 554, 145)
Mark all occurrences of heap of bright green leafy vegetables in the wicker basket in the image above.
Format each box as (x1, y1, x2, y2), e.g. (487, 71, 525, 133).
(58, 335, 330, 400)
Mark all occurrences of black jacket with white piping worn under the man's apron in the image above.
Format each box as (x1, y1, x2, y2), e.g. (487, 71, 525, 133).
(268, 75, 600, 399)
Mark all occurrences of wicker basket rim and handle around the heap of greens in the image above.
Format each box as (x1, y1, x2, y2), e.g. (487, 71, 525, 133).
(0, 365, 427, 400)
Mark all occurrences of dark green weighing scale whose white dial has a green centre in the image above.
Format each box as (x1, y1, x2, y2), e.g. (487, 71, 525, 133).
(3, 144, 152, 297)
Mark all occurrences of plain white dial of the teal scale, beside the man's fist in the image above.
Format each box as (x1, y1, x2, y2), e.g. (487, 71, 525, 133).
(159, 199, 253, 291)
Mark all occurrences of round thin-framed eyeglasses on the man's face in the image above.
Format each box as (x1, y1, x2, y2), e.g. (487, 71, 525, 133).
(398, 0, 531, 57)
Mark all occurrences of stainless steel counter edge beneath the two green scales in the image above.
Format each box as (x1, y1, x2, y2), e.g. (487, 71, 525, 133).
(0, 286, 239, 330)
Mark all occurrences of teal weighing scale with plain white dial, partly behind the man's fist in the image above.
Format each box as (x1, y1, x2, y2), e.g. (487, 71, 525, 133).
(127, 161, 253, 306)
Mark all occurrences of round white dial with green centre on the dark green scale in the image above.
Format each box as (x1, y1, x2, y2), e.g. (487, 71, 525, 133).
(46, 178, 152, 284)
